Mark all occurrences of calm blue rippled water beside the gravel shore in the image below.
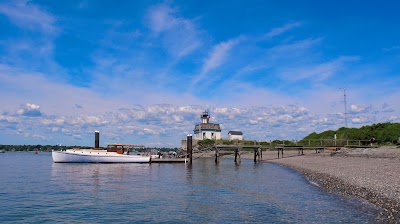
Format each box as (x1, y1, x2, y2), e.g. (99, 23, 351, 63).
(0, 153, 378, 223)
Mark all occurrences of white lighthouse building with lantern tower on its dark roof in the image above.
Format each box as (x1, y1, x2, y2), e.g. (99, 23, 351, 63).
(193, 111, 221, 140)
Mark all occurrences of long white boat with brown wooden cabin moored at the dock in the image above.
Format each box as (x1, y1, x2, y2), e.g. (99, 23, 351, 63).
(52, 144, 151, 163)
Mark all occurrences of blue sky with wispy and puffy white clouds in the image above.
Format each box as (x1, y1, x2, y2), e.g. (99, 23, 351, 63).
(0, 0, 400, 147)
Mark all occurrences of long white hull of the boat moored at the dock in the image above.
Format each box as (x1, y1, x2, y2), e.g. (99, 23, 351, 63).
(52, 150, 150, 163)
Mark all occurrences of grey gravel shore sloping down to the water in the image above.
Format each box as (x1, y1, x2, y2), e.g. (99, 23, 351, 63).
(266, 147, 400, 223)
